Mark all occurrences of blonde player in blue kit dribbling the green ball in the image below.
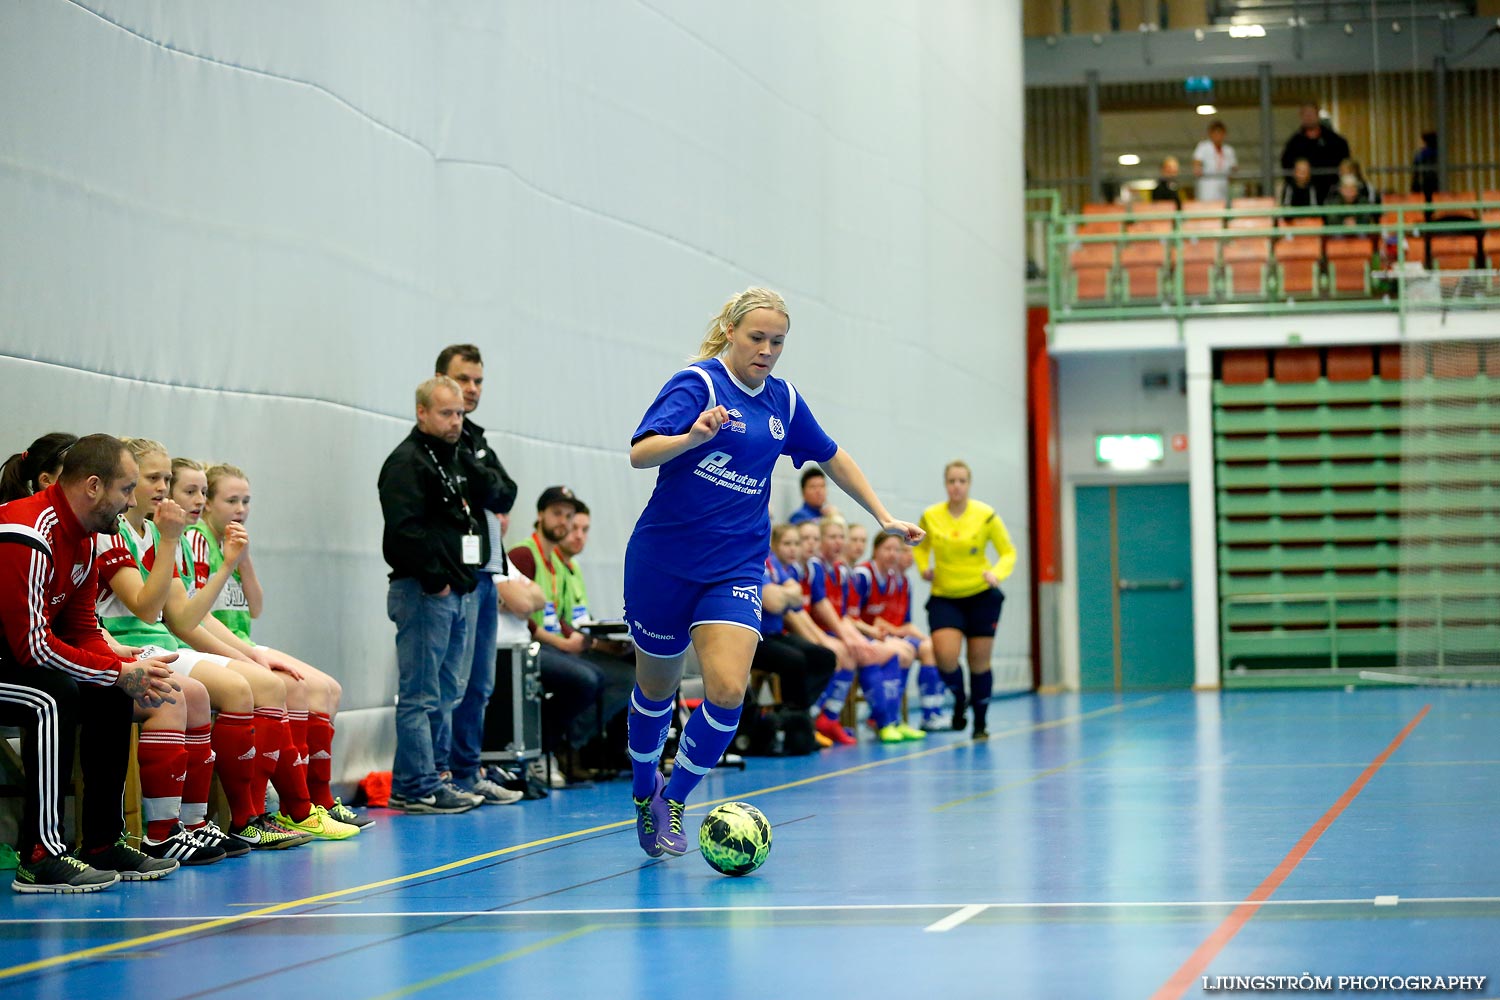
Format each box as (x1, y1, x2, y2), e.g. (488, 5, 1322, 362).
(626, 288, 923, 858)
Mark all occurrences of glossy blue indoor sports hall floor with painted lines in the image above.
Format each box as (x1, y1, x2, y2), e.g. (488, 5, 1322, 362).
(0, 690, 1500, 1000)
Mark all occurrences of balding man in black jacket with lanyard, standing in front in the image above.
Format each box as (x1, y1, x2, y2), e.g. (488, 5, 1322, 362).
(380, 375, 494, 813)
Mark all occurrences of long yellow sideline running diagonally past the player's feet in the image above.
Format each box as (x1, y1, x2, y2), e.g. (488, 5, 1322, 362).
(0, 696, 1163, 979)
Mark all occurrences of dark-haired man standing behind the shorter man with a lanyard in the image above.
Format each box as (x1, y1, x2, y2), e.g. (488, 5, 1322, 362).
(434, 343, 521, 805)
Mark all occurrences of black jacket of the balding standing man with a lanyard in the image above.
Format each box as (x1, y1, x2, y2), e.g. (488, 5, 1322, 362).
(380, 427, 495, 594)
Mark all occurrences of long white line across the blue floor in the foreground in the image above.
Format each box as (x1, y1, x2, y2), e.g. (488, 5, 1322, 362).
(0, 897, 1500, 927)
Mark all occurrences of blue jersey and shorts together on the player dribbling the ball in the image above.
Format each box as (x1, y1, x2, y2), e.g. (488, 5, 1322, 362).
(626, 358, 839, 657)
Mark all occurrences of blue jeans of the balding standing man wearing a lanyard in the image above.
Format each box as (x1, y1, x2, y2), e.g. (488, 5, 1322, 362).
(386, 577, 473, 798)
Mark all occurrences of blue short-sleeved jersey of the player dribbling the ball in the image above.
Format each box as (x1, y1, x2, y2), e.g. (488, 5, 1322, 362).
(630, 358, 839, 583)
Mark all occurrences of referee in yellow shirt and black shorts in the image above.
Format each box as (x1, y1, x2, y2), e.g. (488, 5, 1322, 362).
(914, 462, 1016, 739)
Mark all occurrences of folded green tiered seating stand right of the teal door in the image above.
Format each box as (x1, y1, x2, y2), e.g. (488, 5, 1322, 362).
(1214, 343, 1500, 684)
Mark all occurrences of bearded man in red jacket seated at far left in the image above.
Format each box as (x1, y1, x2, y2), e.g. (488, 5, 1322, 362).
(0, 435, 177, 892)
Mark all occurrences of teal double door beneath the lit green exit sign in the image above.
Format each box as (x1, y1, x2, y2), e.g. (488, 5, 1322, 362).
(1076, 483, 1193, 691)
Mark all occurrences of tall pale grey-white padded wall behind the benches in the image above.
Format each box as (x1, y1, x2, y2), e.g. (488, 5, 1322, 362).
(0, 0, 1029, 772)
